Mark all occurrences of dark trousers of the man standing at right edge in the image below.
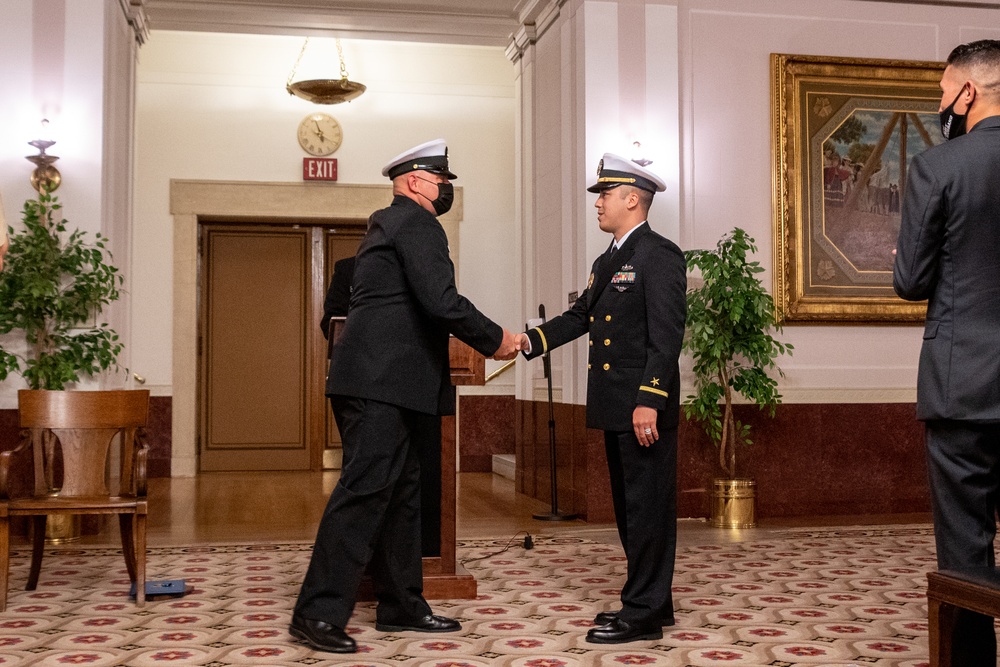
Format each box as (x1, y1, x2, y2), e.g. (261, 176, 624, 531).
(926, 420, 1000, 667)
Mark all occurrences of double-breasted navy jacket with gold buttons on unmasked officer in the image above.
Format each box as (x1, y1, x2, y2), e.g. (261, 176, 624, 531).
(525, 223, 687, 431)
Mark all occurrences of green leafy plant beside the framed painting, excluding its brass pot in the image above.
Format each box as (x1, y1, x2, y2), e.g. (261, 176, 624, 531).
(684, 227, 793, 478)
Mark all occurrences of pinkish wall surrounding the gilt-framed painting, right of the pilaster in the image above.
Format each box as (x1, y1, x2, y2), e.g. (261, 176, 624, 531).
(678, 0, 1000, 403)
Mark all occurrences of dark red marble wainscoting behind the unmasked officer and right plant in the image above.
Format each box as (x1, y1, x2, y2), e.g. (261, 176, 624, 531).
(515, 401, 930, 522)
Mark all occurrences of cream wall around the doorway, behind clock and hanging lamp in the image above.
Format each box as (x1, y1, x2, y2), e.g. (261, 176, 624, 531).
(133, 31, 519, 395)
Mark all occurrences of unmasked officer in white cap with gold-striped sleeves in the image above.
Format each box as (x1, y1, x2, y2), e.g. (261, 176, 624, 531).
(518, 153, 687, 644)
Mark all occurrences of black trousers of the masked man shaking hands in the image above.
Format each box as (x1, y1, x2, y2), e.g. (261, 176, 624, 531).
(295, 396, 430, 628)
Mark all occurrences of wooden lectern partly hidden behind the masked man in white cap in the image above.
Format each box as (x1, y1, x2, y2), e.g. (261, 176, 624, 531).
(329, 317, 486, 600)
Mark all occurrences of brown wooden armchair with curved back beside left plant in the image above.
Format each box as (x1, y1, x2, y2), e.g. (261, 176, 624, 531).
(0, 389, 149, 611)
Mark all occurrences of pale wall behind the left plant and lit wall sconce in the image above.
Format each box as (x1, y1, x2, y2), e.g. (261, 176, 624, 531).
(0, 0, 135, 408)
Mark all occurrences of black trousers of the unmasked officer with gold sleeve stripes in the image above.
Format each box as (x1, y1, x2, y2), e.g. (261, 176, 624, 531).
(604, 428, 677, 627)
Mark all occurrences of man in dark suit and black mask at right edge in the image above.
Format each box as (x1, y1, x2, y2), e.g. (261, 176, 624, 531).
(893, 40, 1000, 667)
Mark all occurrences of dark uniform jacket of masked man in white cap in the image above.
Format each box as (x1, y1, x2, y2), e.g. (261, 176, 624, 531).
(326, 195, 503, 414)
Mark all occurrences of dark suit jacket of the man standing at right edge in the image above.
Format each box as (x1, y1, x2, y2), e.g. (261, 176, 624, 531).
(893, 116, 1000, 423)
